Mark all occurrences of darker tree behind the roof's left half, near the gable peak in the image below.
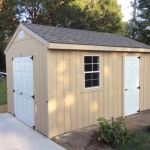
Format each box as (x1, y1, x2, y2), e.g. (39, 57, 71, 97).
(19, 0, 87, 29)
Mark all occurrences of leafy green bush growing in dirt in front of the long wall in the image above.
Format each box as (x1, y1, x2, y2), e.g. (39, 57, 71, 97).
(97, 118, 130, 145)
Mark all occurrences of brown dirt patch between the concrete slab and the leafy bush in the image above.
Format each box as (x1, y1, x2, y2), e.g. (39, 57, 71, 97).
(52, 125, 113, 150)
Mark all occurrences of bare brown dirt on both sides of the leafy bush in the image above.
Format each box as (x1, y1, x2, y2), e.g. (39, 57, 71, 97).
(52, 110, 150, 150)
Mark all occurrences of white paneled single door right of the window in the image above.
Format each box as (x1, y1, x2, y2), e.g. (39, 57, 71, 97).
(125, 56, 140, 116)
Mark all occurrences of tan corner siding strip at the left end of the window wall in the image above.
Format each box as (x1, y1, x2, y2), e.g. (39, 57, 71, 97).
(49, 51, 58, 137)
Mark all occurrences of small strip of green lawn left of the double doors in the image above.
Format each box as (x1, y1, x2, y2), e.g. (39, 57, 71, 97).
(0, 78, 7, 105)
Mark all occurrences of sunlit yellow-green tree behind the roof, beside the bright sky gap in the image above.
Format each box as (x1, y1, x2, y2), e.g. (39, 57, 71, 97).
(80, 0, 124, 34)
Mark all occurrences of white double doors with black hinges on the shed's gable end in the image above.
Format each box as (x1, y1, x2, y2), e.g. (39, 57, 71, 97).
(13, 56, 34, 128)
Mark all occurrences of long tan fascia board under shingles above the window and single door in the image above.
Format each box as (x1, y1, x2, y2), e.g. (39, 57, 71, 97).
(48, 43, 150, 53)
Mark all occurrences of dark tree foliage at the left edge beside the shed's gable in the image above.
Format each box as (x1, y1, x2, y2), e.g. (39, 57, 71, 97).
(0, 0, 19, 69)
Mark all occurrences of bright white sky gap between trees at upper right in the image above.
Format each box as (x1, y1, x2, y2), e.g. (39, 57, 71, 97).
(118, 0, 134, 21)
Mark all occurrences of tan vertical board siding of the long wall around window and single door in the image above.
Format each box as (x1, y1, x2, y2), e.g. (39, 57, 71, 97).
(47, 50, 150, 137)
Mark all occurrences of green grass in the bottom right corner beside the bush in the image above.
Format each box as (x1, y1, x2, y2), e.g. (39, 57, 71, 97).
(116, 127, 150, 150)
